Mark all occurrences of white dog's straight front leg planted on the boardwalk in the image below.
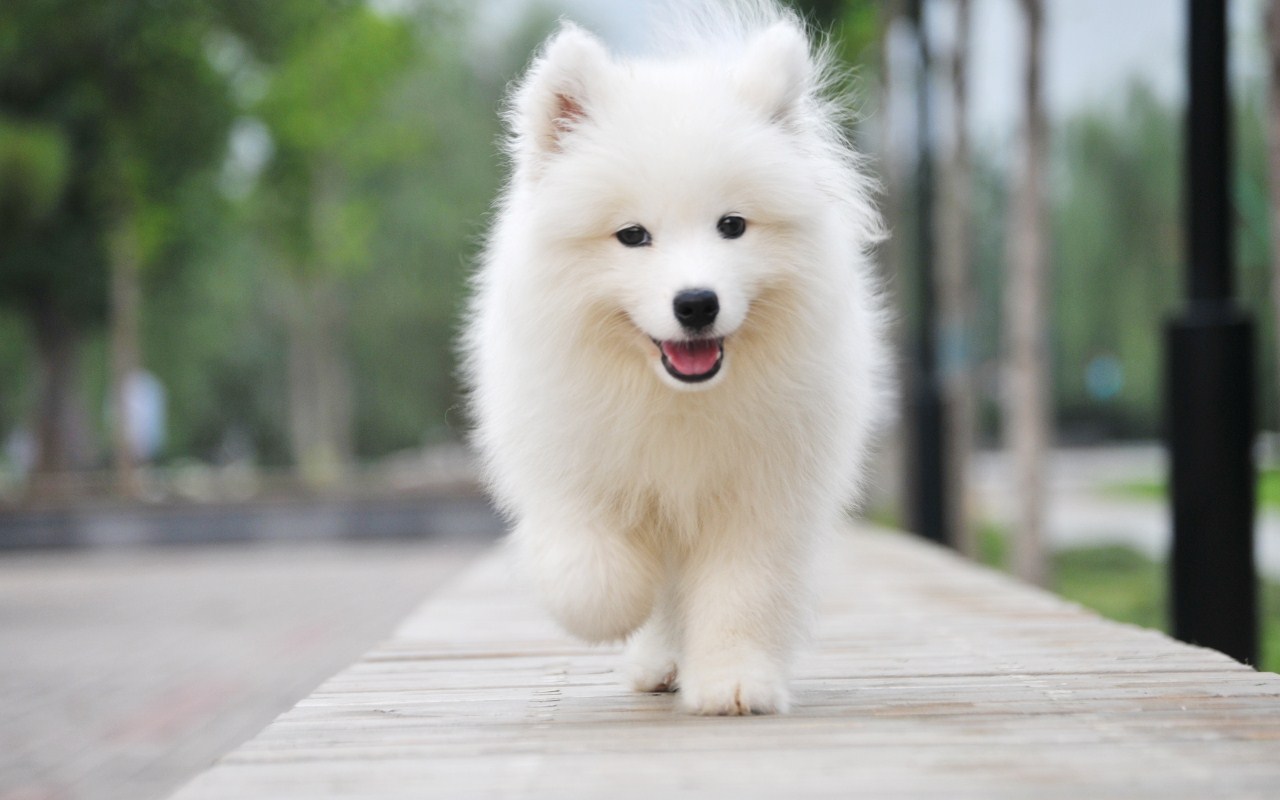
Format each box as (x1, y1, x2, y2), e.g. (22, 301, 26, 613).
(680, 522, 805, 716)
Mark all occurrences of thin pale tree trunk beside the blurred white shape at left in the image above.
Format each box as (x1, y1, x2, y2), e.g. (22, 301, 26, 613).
(110, 219, 142, 498)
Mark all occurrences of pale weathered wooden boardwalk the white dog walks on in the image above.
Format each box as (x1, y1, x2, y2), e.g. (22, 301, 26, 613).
(175, 531, 1280, 800)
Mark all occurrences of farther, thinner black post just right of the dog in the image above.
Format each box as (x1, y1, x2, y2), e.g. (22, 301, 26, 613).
(908, 0, 952, 544)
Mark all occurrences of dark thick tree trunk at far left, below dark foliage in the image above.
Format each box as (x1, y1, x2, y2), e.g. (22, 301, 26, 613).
(31, 303, 88, 498)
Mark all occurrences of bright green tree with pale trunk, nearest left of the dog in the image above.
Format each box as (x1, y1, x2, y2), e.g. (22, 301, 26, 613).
(255, 5, 417, 481)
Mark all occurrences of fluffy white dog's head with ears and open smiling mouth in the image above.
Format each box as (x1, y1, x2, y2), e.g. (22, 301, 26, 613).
(515, 24, 822, 390)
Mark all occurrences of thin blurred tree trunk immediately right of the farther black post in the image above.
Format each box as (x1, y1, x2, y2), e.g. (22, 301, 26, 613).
(938, 0, 979, 558)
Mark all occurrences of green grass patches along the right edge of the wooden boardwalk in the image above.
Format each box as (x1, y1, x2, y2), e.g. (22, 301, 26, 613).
(980, 525, 1280, 672)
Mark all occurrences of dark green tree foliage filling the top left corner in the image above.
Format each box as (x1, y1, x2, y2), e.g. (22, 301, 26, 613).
(0, 0, 238, 232)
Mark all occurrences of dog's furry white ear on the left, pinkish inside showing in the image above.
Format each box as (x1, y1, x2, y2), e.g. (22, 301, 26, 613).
(512, 22, 611, 159)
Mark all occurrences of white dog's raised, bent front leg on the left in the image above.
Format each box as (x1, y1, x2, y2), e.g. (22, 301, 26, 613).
(512, 515, 662, 643)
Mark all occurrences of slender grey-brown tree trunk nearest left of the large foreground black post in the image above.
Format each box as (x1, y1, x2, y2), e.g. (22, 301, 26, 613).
(1002, 0, 1050, 586)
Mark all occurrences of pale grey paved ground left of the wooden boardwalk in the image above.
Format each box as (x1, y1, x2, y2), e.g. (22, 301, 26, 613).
(0, 541, 484, 800)
